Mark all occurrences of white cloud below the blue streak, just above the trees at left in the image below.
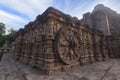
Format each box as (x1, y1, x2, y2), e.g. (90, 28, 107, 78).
(0, 10, 28, 29)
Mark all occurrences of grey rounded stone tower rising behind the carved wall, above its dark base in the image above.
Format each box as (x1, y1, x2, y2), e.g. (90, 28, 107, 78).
(82, 4, 120, 35)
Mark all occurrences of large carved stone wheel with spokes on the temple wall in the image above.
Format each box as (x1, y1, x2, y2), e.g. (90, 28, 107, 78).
(55, 27, 80, 64)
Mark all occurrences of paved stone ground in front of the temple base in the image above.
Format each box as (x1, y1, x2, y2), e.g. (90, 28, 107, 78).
(0, 53, 120, 80)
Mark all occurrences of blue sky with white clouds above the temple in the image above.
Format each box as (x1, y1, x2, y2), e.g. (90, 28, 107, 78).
(0, 0, 120, 30)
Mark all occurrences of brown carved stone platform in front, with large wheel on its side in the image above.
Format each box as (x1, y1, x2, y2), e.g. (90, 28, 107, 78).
(15, 7, 108, 74)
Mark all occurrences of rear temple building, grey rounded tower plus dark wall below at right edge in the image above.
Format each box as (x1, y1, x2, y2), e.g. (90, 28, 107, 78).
(82, 4, 120, 57)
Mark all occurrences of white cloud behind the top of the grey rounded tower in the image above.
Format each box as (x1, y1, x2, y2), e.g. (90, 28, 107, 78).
(67, 0, 120, 19)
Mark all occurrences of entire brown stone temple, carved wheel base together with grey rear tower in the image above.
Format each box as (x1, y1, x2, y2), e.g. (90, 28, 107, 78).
(14, 5, 120, 75)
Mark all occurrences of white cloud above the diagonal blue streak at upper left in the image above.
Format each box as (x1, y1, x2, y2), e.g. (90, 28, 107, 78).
(0, 0, 52, 19)
